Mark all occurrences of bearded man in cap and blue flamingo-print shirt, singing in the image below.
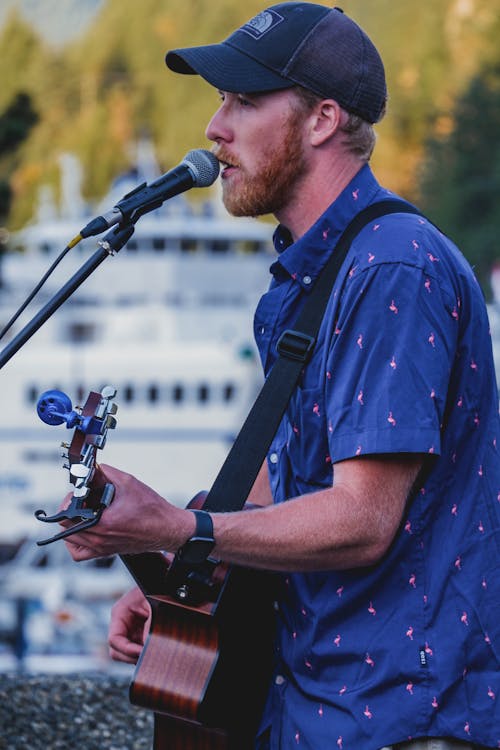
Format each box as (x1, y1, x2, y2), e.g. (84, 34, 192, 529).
(67, 2, 500, 750)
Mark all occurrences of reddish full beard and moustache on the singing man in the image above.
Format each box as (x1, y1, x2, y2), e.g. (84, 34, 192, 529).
(213, 112, 305, 216)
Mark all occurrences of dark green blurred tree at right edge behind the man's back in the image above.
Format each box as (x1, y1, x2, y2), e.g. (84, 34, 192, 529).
(420, 63, 500, 297)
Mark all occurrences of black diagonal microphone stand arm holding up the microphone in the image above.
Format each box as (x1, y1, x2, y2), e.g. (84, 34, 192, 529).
(0, 222, 138, 369)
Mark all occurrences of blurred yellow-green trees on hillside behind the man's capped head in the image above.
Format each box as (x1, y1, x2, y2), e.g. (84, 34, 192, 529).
(0, 0, 500, 280)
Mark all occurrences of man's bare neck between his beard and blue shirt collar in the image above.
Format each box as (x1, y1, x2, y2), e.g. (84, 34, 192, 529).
(275, 158, 364, 242)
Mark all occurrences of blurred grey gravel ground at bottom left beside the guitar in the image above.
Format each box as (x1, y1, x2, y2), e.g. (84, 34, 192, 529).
(0, 673, 153, 750)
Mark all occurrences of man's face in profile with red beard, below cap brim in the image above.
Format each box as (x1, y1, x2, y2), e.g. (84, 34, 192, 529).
(206, 90, 306, 216)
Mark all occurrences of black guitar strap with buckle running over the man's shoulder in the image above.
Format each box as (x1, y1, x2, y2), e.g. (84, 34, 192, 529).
(203, 199, 420, 512)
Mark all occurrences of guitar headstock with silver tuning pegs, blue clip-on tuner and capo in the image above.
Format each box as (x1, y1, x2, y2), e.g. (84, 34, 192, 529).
(35, 386, 118, 545)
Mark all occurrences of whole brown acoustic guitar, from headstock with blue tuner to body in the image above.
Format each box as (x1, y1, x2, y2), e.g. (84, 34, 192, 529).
(35, 387, 275, 750)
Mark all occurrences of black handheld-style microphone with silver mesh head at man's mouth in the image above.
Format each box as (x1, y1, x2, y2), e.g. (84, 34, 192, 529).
(79, 148, 220, 239)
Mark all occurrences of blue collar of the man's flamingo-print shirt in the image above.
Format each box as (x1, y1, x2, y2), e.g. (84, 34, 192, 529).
(271, 164, 381, 291)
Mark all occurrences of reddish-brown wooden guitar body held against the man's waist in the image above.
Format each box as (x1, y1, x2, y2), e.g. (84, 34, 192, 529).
(122, 496, 275, 750)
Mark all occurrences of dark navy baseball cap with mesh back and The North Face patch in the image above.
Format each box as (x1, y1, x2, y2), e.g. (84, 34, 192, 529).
(166, 2, 387, 123)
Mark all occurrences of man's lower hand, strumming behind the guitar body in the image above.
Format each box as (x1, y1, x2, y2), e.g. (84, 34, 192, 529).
(108, 587, 151, 664)
